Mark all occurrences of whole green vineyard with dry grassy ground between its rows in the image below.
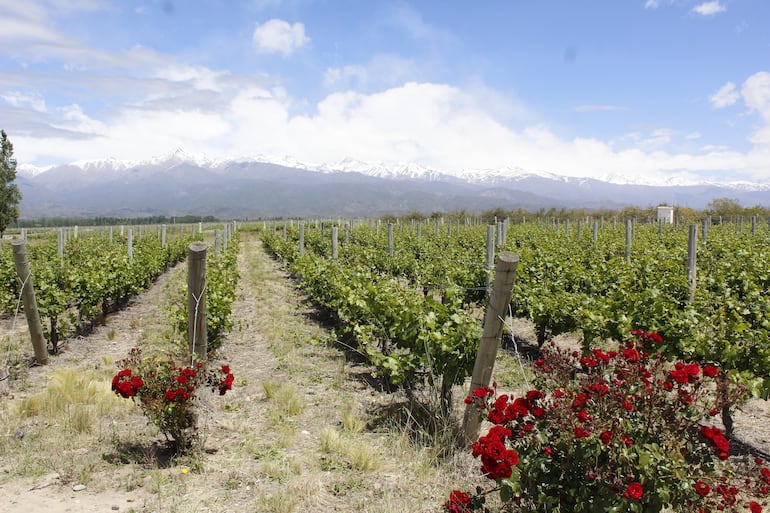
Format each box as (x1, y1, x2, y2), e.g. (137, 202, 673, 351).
(0, 219, 770, 513)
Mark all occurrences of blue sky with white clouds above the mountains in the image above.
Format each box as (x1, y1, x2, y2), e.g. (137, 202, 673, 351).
(0, 0, 770, 184)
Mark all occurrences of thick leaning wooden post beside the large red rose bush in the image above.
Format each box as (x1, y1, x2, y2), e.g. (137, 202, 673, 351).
(463, 251, 519, 443)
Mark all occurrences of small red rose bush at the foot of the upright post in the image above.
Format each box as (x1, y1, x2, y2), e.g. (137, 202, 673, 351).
(112, 348, 235, 450)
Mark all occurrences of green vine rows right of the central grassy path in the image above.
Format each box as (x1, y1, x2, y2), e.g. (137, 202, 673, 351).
(263, 218, 770, 397)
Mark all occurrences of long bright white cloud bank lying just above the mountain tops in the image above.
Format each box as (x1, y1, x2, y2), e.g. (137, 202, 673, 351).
(14, 80, 770, 180)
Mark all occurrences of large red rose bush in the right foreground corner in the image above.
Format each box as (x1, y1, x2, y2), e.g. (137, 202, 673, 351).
(444, 330, 770, 513)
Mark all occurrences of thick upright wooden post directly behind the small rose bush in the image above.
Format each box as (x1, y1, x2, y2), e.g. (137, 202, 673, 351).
(187, 242, 208, 361)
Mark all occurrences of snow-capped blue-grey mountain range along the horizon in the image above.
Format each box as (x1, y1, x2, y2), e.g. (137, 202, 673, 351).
(16, 150, 770, 219)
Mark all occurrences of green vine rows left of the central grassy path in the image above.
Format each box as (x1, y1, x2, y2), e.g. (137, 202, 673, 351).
(0, 228, 238, 351)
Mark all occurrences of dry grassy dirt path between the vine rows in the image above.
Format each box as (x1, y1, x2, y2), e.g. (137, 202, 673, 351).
(0, 234, 471, 513)
